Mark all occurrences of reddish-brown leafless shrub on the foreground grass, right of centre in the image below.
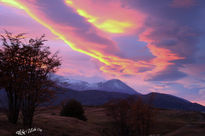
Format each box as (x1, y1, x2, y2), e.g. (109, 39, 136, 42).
(106, 97, 153, 136)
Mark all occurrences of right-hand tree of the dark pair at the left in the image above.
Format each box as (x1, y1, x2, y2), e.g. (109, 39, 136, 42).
(22, 36, 60, 126)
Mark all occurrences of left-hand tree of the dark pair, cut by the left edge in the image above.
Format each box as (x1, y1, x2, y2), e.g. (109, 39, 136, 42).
(0, 32, 23, 124)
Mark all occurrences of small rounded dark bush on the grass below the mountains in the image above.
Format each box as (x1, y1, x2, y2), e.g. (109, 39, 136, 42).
(60, 99, 87, 121)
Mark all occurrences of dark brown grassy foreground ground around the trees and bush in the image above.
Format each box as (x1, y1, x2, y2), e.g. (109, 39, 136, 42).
(0, 107, 205, 136)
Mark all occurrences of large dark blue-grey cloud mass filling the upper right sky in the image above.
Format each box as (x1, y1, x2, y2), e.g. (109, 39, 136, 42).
(123, 0, 205, 81)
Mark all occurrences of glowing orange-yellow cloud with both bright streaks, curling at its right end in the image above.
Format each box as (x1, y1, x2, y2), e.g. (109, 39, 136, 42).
(0, 0, 182, 76)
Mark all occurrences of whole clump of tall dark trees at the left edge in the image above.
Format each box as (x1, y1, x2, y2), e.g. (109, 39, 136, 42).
(0, 32, 60, 127)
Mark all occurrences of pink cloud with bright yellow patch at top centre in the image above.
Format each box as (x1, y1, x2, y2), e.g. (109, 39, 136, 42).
(65, 0, 144, 34)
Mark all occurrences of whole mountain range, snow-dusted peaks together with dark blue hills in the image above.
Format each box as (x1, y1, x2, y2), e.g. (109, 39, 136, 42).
(0, 75, 205, 112)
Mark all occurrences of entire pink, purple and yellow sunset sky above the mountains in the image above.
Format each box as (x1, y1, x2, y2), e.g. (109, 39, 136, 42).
(0, 0, 205, 105)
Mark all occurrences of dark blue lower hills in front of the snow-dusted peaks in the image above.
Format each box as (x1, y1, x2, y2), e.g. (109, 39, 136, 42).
(55, 88, 205, 112)
